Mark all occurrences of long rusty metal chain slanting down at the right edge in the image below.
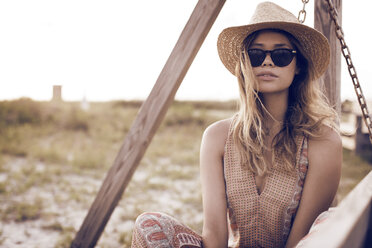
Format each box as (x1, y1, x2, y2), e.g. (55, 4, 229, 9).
(327, 0, 372, 144)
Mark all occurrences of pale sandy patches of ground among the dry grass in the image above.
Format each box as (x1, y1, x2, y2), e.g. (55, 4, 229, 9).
(0, 158, 202, 248)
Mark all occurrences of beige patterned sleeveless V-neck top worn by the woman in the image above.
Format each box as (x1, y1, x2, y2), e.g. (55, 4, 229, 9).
(224, 121, 308, 248)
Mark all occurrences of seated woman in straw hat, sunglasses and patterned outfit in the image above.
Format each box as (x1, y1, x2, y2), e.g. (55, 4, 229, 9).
(133, 2, 342, 248)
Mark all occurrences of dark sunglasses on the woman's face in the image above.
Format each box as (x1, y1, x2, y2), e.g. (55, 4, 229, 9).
(248, 48, 296, 67)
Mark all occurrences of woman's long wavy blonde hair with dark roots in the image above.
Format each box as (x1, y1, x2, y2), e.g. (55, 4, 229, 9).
(232, 30, 338, 175)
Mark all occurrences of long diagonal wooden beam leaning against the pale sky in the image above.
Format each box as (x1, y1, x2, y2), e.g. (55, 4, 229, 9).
(71, 0, 225, 247)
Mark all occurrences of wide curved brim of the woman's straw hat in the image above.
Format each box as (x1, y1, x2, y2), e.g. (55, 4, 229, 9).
(217, 21, 330, 79)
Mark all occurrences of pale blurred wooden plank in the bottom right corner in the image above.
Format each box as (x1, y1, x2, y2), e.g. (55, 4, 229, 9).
(301, 172, 372, 248)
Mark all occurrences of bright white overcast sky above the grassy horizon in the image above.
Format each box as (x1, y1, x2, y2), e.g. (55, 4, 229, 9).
(0, 0, 372, 101)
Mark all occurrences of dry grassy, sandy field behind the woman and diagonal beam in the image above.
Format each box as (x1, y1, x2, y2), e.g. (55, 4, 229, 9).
(0, 99, 371, 247)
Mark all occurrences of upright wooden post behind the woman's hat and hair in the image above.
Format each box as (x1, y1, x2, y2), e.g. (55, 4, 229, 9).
(314, 0, 342, 115)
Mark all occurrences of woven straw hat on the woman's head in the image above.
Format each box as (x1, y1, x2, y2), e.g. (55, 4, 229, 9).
(217, 2, 330, 79)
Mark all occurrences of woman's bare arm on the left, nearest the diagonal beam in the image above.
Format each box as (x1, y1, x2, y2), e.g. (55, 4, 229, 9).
(200, 120, 230, 248)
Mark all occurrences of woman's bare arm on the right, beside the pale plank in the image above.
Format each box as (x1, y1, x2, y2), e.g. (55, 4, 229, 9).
(286, 127, 342, 248)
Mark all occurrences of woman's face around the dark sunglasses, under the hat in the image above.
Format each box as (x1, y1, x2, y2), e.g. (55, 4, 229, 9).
(249, 31, 298, 94)
